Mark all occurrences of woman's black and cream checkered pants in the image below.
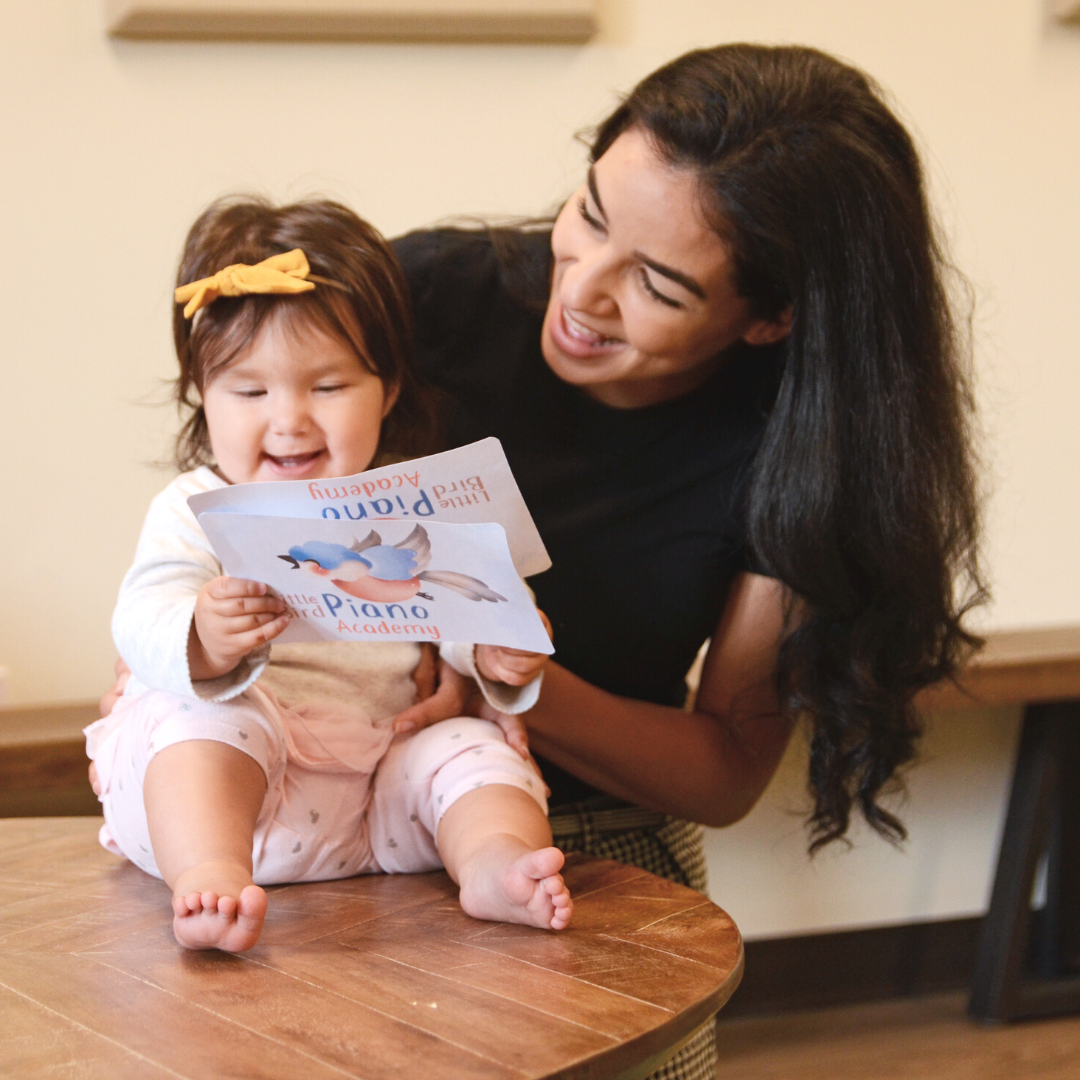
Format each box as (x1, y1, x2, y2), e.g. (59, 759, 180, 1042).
(551, 802, 716, 1080)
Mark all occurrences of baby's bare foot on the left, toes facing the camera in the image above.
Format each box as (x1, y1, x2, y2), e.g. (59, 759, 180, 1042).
(173, 863, 267, 953)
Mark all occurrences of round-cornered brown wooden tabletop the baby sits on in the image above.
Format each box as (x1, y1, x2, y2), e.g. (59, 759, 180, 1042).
(0, 818, 743, 1080)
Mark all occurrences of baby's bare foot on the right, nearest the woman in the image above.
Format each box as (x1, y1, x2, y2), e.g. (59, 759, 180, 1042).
(460, 841, 573, 930)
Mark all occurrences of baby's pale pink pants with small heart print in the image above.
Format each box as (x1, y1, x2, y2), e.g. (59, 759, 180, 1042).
(85, 686, 548, 885)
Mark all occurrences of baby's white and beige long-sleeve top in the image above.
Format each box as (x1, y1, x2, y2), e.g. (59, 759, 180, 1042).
(112, 465, 540, 720)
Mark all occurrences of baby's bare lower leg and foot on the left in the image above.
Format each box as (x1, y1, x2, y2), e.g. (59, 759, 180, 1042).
(143, 740, 267, 953)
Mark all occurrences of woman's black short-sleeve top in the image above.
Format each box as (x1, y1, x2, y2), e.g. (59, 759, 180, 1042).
(393, 229, 778, 807)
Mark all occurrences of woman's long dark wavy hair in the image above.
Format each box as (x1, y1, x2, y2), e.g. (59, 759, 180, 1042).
(592, 44, 985, 848)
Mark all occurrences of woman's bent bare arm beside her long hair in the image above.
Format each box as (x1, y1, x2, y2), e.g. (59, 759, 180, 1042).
(524, 573, 793, 825)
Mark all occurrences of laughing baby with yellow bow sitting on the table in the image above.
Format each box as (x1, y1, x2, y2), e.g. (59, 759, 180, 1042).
(86, 200, 572, 951)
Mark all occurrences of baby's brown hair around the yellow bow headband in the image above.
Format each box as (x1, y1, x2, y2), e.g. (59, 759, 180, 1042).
(173, 197, 438, 471)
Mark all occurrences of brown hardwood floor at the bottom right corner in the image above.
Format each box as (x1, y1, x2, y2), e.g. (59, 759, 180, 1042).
(717, 994, 1080, 1080)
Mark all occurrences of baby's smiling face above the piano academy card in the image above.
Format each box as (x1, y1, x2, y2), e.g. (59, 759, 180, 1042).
(203, 320, 393, 484)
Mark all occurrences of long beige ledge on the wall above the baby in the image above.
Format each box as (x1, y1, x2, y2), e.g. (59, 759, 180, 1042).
(105, 0, 597, 43)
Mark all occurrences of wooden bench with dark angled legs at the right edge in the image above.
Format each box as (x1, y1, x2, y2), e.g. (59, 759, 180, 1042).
(919, 626, 1080, 1022)
